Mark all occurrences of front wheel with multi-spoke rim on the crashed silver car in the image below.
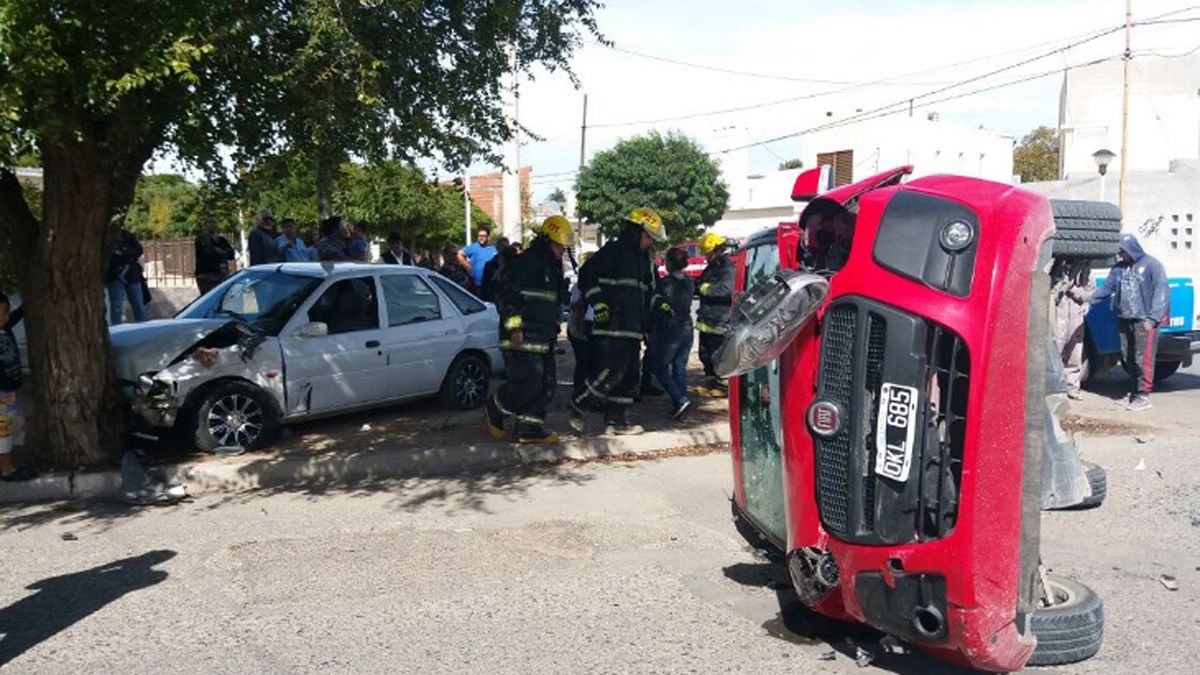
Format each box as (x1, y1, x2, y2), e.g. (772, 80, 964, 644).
(192, 380, 280, 452)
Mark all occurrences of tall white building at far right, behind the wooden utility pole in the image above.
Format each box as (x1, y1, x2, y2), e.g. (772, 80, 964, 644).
(1058, 53, 1200, 179)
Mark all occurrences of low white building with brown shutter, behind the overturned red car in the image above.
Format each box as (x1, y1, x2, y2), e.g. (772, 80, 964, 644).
(713, 115, 1013, 238)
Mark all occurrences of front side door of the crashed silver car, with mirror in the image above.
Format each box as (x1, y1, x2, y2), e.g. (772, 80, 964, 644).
(280, 274, 388, 413)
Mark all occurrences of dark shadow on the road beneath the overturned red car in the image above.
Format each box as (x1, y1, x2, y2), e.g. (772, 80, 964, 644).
(722, 560, 973, 675)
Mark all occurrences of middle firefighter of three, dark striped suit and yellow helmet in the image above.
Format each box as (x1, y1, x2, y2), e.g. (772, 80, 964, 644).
(571, 209, 667, 436)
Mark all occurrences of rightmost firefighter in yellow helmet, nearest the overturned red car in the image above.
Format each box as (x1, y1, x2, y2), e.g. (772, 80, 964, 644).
(696, 232, 733, 398)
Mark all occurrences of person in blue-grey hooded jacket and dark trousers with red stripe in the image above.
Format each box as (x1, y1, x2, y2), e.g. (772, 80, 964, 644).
(1092, 234, 1171, 411)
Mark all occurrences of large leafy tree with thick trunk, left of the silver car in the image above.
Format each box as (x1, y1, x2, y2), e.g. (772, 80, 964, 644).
(0, 0, 599, 467)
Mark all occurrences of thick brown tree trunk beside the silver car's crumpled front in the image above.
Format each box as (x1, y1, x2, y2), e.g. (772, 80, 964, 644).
(5, 143, 121, 468)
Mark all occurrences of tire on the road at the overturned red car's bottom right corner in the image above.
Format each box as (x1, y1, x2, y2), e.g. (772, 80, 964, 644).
(1028, 575, 1104, 665)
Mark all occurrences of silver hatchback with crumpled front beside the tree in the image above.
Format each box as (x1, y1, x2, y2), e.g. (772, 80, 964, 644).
(112, 263, 504, 449)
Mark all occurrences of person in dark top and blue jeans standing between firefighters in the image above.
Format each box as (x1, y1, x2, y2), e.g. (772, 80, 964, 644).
(647, 249, 695, 419)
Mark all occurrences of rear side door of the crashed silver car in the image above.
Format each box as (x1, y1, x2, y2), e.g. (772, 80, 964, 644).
(379, 269, 466, 398)
